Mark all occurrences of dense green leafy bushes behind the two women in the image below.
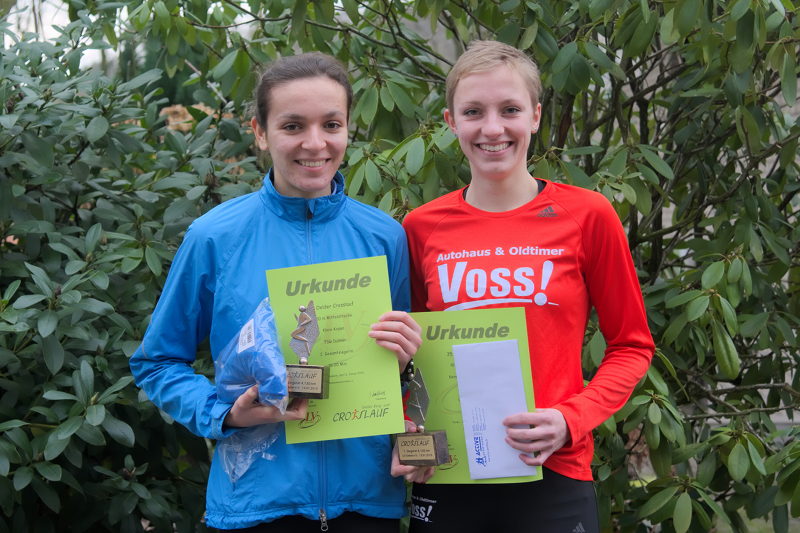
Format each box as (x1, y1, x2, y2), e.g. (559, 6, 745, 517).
(0, 0, 800, 533)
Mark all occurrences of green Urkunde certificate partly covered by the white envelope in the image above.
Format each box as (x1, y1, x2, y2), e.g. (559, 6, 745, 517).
(411, 307, 541, 483)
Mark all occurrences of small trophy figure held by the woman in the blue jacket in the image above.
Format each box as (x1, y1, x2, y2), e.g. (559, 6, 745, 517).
(286, 300, 330, 400)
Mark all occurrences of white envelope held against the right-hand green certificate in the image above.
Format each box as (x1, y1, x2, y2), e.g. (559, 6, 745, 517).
(453, 340, 537, 479)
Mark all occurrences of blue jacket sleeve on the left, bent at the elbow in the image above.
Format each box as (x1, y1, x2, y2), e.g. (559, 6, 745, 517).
(130, 222, 236, 439)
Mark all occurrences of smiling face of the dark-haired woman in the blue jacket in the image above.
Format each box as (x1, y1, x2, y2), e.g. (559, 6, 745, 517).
(252, 76, 347, 198)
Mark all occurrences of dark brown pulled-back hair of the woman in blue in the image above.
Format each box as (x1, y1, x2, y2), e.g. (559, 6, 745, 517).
(253, 52, 353, 131)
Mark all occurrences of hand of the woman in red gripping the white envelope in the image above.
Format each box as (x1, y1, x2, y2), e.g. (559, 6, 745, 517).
(503, 409, 570, 466)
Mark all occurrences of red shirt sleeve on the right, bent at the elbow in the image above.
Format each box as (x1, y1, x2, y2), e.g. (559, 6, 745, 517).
(555, 195, 655, 441)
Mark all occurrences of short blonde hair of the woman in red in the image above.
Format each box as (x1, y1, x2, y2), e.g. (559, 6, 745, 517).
(445, 41, 542, 111)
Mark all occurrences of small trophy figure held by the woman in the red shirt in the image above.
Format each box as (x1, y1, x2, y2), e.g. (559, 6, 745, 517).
(396, 369, 450, 466)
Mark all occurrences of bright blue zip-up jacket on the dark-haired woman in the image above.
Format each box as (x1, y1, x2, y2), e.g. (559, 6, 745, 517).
(130, 173, 409, 529)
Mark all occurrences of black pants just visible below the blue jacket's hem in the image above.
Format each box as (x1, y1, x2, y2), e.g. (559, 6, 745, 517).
(217, 513, 400, 533)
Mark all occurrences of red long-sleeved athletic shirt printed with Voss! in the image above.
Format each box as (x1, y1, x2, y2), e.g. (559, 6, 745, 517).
(403, 180, 654, 480)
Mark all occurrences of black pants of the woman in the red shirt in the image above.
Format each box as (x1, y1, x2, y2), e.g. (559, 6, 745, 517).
(409, 468, 600, 533)
